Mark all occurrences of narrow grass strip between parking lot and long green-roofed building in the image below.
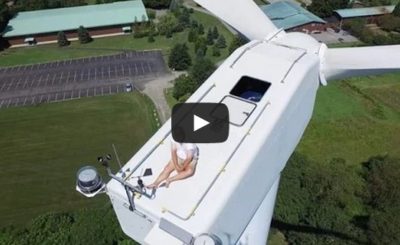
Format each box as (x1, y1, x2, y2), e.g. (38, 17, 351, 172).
(0, 11, 233, 66)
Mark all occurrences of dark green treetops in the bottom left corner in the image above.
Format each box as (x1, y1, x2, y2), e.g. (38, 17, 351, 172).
(0, 205, 137, 245)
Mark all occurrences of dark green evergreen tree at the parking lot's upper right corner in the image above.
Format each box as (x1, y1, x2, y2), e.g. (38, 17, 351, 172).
(168, 43, 192, 71)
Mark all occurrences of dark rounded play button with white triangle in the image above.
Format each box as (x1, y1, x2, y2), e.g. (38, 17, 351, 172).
(171, 103, 229, 143)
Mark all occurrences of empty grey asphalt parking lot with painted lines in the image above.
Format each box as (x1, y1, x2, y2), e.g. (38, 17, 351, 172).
(0, 51, 166, 108)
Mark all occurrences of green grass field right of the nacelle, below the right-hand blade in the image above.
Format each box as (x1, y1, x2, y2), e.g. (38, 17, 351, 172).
(298, 73, 400, 167)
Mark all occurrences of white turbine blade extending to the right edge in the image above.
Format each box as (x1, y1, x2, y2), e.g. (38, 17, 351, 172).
(322, 45, 400, 80)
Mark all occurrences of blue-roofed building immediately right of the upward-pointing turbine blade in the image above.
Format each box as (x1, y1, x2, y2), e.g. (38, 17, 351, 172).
(260, 1, 326, 32)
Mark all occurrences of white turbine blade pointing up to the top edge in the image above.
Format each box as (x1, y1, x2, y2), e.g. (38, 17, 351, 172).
(194, 0, 278, 40)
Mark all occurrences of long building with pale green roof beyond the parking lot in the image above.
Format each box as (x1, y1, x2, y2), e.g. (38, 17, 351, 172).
(3, 0, 148, 45)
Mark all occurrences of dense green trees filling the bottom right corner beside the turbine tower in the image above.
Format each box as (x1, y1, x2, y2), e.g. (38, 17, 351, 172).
(272, 153, 400, 244)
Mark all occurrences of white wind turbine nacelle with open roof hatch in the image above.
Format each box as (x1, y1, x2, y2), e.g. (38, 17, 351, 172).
(107, 39, 320, 244)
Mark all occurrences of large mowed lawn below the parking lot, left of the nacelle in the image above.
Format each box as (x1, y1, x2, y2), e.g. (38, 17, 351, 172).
(0, 93, 156, 227)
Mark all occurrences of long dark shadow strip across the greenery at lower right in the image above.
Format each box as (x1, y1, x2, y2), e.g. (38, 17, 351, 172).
(271, 219, 367, 244)
